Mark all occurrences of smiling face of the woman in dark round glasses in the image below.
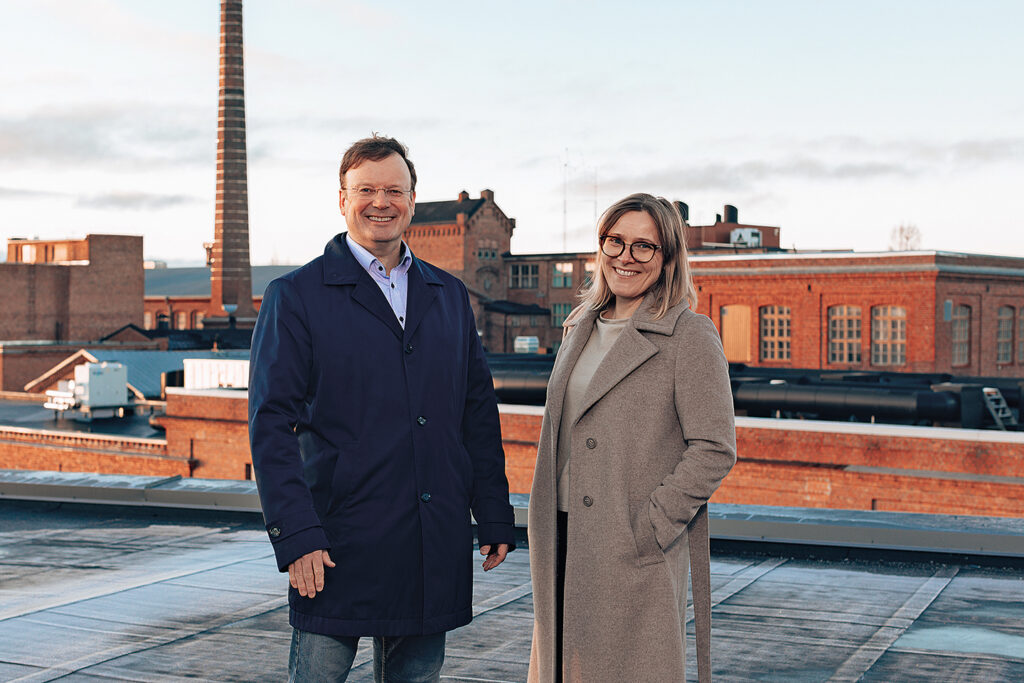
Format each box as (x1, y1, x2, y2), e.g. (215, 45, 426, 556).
(599, 211, 665, 308)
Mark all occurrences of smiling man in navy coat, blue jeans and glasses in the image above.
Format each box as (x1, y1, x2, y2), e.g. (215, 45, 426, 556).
(249, 135, 515, 681)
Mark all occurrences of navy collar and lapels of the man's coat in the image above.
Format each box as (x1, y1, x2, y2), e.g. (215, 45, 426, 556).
(324, 232, 443, 339)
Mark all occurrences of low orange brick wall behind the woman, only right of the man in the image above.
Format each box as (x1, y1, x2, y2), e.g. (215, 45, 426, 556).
(493, 405, 1024, 517)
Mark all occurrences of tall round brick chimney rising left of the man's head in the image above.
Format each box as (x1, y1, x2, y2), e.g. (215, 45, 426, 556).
(210, 0, 256, 318)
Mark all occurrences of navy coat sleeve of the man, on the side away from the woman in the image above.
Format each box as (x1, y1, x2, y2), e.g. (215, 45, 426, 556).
(249, 280, 329, 571)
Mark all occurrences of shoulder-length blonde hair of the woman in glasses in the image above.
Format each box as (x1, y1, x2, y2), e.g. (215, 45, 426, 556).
(580, 193, 697, 319)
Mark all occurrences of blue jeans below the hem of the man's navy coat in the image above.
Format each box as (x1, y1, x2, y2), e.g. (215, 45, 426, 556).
(288, 629, 445, 683)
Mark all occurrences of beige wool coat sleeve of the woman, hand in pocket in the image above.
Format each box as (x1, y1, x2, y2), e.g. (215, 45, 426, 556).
(648, 315, 736, 549)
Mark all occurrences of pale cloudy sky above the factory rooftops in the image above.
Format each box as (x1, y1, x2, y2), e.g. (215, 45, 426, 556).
(0, 0, 1024, 265)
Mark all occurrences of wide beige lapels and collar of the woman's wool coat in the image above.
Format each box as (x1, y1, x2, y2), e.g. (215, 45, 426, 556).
(548, 294, 688, 422)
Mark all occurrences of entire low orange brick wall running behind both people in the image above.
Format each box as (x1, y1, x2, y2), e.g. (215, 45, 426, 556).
(8, 389, 1024, 517)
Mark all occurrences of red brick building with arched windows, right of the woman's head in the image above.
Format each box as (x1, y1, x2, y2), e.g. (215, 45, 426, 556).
(691, 252, 1024, 377)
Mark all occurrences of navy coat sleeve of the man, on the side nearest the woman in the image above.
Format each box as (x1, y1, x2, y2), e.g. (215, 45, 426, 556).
(462, 282, 515, 550)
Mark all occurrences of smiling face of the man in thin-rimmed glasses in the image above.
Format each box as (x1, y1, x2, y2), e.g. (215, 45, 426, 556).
(339, 155, 416, 256)
